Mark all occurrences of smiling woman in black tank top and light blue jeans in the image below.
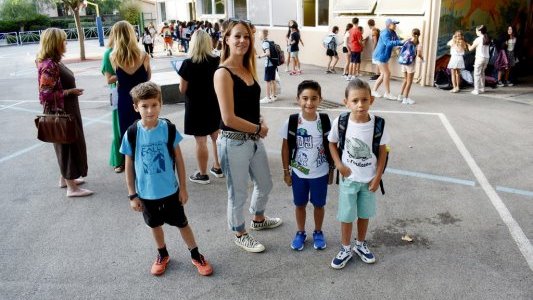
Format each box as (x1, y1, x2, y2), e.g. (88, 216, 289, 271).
(214, 20, 282, 252)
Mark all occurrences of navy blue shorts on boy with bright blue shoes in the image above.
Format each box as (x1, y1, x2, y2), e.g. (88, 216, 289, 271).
(292, 172, 329, 208)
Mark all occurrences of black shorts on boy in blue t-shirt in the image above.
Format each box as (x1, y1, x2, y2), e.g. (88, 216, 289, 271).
(141, 189, 189, 228)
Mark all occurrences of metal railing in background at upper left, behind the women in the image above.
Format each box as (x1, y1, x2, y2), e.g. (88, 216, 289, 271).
(0, 25, 140, 47)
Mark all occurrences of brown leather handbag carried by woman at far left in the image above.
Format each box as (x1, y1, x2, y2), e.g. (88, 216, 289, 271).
(35, 99, 78, 144)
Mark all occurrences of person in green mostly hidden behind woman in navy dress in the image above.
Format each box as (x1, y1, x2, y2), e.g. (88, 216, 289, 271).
(101, 32, 124, 173)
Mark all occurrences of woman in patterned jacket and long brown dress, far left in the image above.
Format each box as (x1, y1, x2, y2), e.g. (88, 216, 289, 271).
(36, 28, 93, 197)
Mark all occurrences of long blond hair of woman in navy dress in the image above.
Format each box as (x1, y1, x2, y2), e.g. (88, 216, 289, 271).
(111, 21, 141, 68)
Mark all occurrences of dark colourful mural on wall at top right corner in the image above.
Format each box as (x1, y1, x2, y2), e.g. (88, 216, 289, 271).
(437, 0, 533, 57)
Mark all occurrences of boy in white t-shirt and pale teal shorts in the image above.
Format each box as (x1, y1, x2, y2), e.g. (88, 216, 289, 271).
(328, 79, 390, 269)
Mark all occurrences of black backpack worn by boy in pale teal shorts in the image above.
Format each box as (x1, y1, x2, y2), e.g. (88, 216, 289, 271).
(337, 112, 389, 195)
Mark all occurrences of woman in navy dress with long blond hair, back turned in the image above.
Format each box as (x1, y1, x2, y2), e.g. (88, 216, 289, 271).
(111, 21, 151, 140)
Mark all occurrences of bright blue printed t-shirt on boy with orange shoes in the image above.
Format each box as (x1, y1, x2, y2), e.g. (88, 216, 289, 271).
(120, 119, 183, 200)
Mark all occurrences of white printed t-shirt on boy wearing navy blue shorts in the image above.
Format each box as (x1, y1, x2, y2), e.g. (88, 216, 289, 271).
(279, 113, 329, 178)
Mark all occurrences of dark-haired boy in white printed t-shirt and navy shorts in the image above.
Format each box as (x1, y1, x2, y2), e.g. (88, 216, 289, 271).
(279, 80, 331, 251)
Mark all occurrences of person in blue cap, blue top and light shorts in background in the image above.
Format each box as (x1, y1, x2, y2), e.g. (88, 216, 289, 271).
(372, 19, 403, 100)
